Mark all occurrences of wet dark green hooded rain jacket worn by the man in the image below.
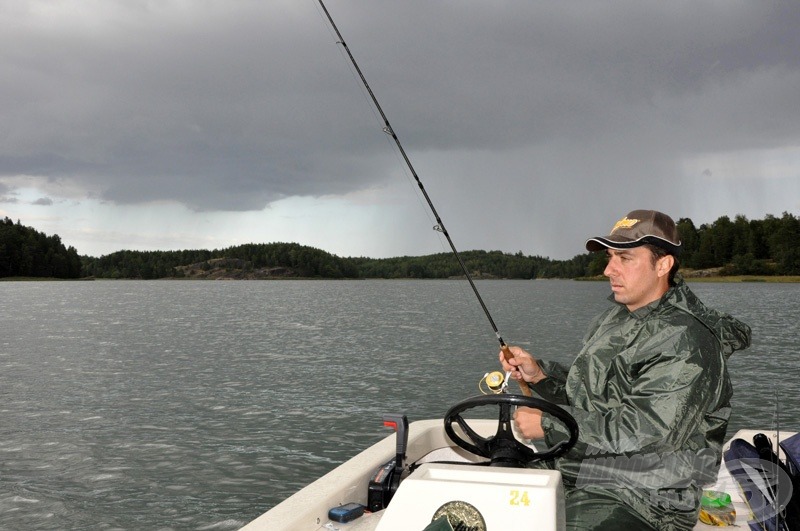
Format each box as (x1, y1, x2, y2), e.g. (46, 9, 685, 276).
(529, 276, 750, 529)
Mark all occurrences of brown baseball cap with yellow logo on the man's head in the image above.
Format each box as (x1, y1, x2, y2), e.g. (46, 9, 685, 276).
(586, 210, 681, 256)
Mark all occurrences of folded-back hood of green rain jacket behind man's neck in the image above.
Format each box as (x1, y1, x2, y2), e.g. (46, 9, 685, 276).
(665, 275, 751, 358)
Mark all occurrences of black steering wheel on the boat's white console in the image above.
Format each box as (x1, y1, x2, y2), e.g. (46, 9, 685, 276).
(444, 394, 578, 468)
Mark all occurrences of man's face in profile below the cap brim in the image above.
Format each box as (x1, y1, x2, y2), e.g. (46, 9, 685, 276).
(603, 247, 672, 311)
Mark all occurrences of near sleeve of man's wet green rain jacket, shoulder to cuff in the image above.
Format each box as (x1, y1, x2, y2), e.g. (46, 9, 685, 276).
(542, 326, 730, 459)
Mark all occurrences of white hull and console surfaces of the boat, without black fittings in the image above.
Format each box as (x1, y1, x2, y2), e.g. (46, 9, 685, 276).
(243, 426, 791, 531)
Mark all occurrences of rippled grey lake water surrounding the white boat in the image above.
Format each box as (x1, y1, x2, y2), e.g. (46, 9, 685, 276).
(0, 280, 800, 530)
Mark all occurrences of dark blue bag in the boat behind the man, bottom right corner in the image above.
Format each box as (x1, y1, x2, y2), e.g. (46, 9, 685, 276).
(724, 433, 800, 531)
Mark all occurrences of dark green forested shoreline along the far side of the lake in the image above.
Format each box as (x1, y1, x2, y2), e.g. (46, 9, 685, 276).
(0, 212, 800, 279)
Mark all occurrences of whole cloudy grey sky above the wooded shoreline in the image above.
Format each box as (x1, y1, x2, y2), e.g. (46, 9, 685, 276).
(0, 0, 800, 258)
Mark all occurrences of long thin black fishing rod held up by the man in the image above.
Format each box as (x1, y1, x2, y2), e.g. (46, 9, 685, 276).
(317, 0, 531, 396)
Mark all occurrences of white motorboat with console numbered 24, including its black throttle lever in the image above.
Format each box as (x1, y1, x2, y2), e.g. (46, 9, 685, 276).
(243, 394, 798, 531)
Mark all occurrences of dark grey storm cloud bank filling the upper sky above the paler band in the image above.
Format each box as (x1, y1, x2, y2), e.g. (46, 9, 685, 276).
(0, 0, 800, 231)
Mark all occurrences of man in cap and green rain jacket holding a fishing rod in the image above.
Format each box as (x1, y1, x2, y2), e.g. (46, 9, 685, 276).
(500, 210, 750, 531)
